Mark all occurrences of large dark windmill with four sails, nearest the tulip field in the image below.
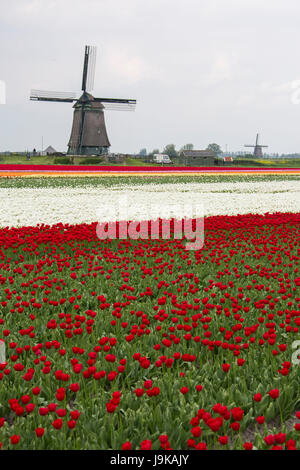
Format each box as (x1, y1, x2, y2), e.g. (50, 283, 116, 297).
(30, 46, 136, 155)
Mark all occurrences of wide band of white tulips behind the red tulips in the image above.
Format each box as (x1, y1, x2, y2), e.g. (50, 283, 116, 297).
(0, 177, 300, 227)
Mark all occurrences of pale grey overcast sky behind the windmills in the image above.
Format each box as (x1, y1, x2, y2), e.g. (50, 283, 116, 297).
(0, 0, 300, 153)
